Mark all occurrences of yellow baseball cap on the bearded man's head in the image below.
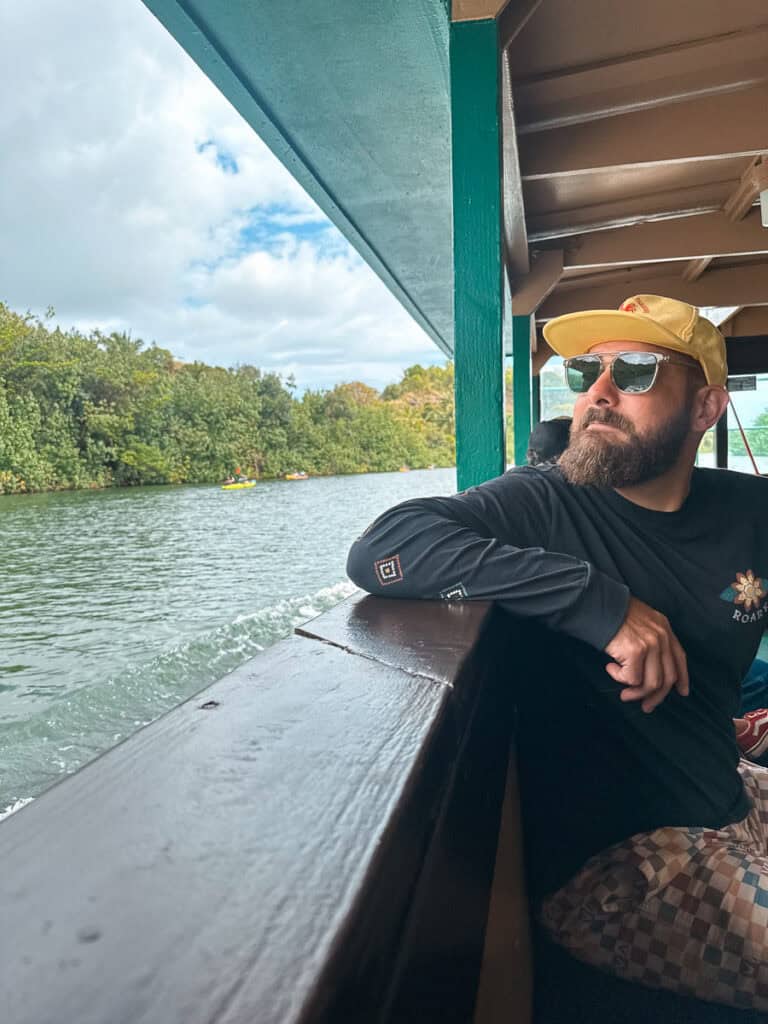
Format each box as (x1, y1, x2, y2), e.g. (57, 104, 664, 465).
(544, 295, 728, 386)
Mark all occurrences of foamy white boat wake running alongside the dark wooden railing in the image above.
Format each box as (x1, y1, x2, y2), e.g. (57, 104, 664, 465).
(0, 581, 355, 820)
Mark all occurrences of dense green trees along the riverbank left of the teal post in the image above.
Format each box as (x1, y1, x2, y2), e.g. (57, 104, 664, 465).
(0, 303, 455, 494)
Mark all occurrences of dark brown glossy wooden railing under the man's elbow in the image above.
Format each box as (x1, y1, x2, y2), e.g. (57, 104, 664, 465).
(0, 598, 527, 1024)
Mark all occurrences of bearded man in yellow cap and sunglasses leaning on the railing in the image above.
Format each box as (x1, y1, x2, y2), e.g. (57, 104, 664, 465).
(348, 295, 768, 1009)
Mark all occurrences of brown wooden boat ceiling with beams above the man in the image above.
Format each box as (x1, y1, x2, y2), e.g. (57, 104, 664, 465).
(505, 0, 768, 368)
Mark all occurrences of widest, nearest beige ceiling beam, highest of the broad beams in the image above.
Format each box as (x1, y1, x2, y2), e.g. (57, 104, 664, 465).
(518, 85, 768, 181)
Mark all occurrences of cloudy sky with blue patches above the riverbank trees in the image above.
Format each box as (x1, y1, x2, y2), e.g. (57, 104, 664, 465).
(0, 0, 444, 390)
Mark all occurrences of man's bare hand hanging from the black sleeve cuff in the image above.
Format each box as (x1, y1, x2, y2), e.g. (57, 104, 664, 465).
(605, 597, 688, 712)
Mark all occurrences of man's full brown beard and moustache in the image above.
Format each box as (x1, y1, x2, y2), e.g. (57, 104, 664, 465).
(559, 403, 690, 487)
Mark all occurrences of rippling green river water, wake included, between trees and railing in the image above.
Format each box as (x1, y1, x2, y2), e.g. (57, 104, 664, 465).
(0, 469, 456, 813)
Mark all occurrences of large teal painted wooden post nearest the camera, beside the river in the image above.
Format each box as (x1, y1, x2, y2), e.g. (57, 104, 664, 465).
(451, 19, 506, 490)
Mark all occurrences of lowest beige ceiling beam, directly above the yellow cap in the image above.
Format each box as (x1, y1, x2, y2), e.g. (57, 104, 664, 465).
(538, 262, 768, 318)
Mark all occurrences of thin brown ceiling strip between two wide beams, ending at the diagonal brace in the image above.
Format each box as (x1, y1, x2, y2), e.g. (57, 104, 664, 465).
(528, 181, 731, 243)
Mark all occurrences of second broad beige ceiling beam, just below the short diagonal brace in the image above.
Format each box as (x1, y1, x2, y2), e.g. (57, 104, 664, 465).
(564, 210, 768, 272)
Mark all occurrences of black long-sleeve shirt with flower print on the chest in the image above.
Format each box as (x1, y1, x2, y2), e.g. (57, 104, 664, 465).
(347, 466, 768, 894)
